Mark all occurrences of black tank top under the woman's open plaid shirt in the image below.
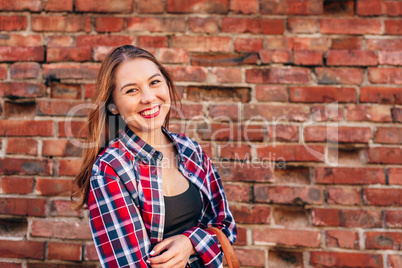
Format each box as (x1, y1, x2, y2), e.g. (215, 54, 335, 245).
(163, 182, 202, 238)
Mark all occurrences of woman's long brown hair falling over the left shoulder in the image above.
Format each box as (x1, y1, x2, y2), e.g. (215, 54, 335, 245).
(71, 45, 178, 210)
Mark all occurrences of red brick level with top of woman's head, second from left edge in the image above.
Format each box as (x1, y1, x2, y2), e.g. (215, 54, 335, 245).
(46, 47, 92, 62)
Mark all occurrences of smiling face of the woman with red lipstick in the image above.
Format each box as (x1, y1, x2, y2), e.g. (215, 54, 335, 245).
(113, 58, 170, 135)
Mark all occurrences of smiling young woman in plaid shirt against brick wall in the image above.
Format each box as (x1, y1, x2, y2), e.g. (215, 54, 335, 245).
(73, 45, 236, 268)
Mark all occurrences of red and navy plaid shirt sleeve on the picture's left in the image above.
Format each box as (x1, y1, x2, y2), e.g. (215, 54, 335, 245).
(88, 161, 150, 267)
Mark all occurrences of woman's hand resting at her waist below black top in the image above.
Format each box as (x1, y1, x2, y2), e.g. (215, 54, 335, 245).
(147, 235, 195, 268)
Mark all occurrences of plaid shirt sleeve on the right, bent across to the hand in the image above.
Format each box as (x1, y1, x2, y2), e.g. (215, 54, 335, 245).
(183, 149, 237, 268)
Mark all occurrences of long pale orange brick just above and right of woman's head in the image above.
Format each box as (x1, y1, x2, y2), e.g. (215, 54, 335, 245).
(170, 35, 232, 52)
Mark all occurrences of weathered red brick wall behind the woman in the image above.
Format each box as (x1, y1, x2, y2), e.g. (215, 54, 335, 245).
(0, 0, 402, 268)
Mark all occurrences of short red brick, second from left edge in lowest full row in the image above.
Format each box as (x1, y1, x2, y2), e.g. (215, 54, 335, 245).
(47, 242, 82, 261)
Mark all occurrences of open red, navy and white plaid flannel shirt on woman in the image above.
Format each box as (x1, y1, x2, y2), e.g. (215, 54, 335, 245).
(87, 127, 236, 267)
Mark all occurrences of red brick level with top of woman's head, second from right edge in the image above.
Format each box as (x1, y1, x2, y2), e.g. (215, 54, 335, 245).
(327, 50, 378, 66)
